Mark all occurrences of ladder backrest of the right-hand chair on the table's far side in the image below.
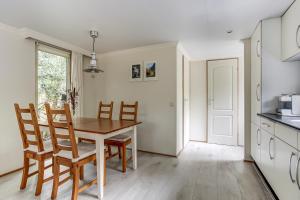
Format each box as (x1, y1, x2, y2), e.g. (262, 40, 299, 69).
(120, 101, 138, 122)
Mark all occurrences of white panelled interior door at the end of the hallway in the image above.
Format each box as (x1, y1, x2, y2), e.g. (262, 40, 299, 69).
(208, 59, 238, 145)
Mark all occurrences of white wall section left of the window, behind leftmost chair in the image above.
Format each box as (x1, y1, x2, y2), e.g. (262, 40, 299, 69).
(0, 24, 35, 174)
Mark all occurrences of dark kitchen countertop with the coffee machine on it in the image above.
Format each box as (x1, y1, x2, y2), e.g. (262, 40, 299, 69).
(257, 113, 300, 130)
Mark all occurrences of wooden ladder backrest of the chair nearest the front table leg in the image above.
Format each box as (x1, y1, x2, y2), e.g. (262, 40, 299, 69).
(45, 103, 79, 159)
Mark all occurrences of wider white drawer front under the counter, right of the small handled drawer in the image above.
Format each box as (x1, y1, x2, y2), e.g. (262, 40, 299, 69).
(275, 124, 298, 148)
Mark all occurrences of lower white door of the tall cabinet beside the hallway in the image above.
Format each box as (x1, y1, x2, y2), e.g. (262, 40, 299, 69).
(251, 123, 261, 165)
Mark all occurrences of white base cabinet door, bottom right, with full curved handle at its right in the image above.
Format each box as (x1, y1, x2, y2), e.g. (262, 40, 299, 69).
(272, 138, 300, 199)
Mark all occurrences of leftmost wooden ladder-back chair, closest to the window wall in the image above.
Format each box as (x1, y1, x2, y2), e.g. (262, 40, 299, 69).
(14, 103, 53, 196)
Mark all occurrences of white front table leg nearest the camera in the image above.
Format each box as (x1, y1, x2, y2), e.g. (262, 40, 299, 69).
(96, 136, 105, 199)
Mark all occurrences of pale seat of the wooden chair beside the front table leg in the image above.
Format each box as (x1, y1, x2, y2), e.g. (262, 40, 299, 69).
(54, 141, 96, 162)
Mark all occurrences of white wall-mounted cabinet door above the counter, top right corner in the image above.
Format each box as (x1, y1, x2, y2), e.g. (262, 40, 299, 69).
(282, 0, 300, 60)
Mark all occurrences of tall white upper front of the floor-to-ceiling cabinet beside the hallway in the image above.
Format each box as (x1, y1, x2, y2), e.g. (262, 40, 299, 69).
(251, 23, 261, 125)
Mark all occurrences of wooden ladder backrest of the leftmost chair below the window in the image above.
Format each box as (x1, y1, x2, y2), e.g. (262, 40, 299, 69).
(14, 103, 44, 152)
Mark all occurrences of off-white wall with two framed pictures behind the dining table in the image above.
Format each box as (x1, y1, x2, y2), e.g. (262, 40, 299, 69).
(95, 43, 177, 156)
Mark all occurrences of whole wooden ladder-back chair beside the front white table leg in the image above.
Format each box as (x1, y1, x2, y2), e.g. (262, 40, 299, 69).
(45, 103, 106, 200)
